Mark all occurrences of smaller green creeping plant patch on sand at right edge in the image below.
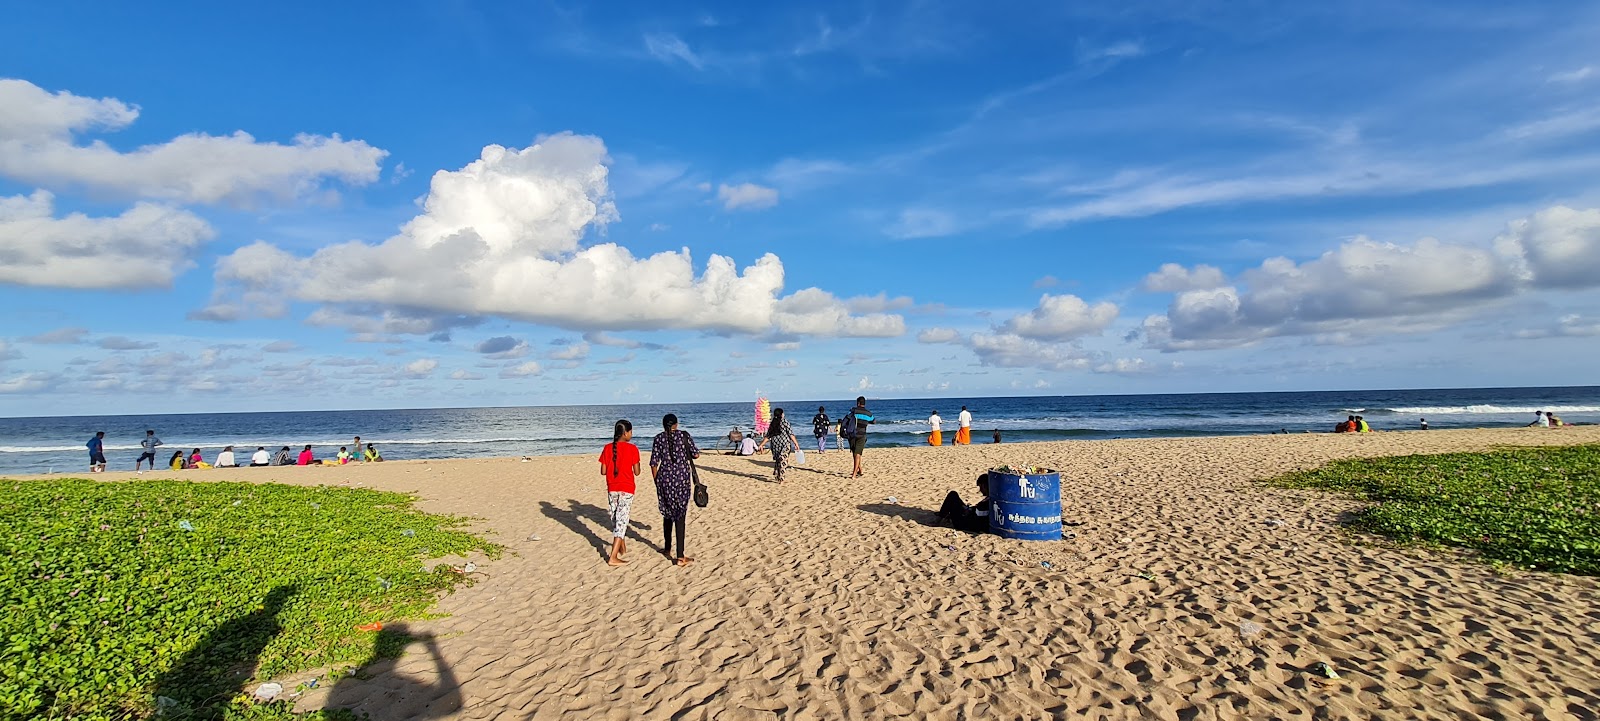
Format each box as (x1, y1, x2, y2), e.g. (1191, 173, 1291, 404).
(1266, 446, 1600, 576)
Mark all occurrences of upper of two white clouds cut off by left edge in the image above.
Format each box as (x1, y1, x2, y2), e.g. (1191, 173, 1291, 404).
(0, 78, 387, 205)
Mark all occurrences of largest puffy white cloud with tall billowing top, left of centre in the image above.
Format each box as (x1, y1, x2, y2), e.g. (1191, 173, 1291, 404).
(197, 134, 904, 336)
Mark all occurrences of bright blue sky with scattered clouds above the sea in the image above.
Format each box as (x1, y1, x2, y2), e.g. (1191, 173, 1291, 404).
(0, 2, 1600, 416)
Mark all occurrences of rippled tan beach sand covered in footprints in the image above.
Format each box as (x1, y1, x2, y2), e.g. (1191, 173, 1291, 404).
(43, 427, 1600, 719)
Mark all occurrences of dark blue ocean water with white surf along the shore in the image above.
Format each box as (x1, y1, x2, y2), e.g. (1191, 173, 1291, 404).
(0, 385, 1600, 473)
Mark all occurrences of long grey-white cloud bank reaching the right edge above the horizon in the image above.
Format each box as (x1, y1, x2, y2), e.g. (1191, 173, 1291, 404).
(1142, 206, 1600, 350)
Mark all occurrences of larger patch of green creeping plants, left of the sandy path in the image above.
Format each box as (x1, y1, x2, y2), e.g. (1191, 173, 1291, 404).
(0, 480, 501, 719)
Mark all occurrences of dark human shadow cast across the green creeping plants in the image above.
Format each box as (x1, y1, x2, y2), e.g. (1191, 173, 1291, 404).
(154, 585, 296, 719)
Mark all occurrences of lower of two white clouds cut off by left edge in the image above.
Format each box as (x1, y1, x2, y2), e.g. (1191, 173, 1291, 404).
(0, 190, 214, 289)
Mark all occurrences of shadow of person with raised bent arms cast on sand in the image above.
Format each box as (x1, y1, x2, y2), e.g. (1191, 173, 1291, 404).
(323, 623, 461, 719)
